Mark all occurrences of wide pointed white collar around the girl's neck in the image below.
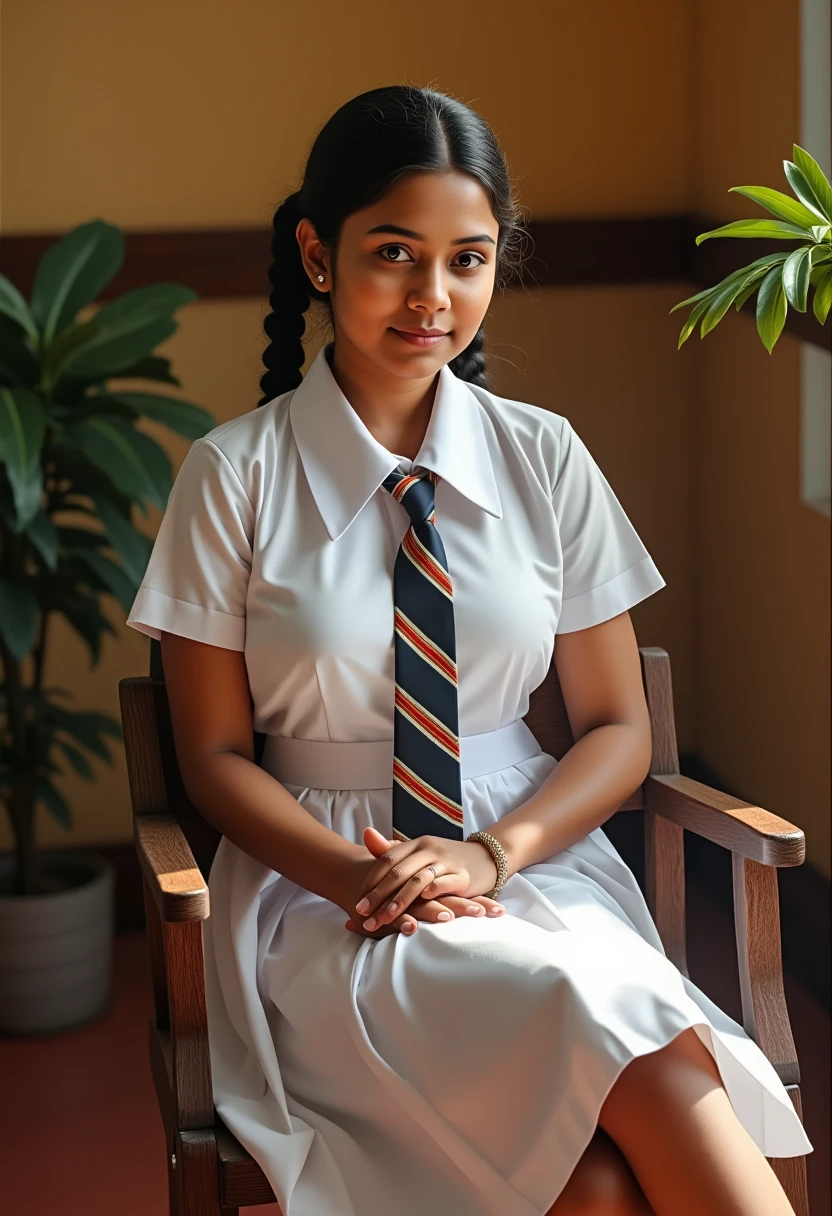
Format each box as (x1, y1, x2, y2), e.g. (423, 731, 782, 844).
(289, 343, 502, 540)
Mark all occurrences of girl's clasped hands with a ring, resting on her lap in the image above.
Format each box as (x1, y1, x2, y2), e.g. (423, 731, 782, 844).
(345, 827, 505, 936)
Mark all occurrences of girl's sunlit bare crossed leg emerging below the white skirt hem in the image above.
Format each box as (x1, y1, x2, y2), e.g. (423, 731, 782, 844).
(598, 1026, 793, 1216)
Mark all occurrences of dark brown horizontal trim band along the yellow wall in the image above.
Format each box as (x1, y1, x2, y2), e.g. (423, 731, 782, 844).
(0, 214, 832, 350)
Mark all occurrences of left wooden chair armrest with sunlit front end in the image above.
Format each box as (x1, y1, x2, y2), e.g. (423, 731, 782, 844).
(133, 815, 209, 923)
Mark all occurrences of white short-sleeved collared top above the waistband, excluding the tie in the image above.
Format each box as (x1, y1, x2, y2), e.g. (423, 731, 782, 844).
(128, 344, 665, 742)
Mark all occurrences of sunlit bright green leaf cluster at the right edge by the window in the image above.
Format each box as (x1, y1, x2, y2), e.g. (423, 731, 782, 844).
(670, 143, 832, 354)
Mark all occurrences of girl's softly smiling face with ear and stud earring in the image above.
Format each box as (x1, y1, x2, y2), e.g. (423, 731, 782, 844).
(297, 170, 499, 379)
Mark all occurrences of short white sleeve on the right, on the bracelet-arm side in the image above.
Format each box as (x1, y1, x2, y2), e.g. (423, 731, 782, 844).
(552, 418, 665, 634)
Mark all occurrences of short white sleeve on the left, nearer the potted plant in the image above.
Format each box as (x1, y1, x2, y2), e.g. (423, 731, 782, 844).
(127, 438, 254, 651)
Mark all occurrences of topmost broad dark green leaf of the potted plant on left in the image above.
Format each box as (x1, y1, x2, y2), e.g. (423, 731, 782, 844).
(32, 220, 124, 347)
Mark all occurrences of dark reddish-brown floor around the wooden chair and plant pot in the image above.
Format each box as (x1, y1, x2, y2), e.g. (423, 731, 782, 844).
(0, 890, 831, 1216)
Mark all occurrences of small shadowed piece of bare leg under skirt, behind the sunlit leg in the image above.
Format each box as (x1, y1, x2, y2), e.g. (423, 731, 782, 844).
(546, 1127, 653, 1216)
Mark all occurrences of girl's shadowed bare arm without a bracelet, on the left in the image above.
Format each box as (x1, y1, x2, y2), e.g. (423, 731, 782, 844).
(162, 632, 360, 902)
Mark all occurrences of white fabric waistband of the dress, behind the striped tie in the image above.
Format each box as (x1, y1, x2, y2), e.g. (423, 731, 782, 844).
(260, 717, 543, 789)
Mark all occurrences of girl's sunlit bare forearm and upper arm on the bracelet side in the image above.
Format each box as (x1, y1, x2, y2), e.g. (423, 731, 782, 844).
(489, 612, 652, 876)
